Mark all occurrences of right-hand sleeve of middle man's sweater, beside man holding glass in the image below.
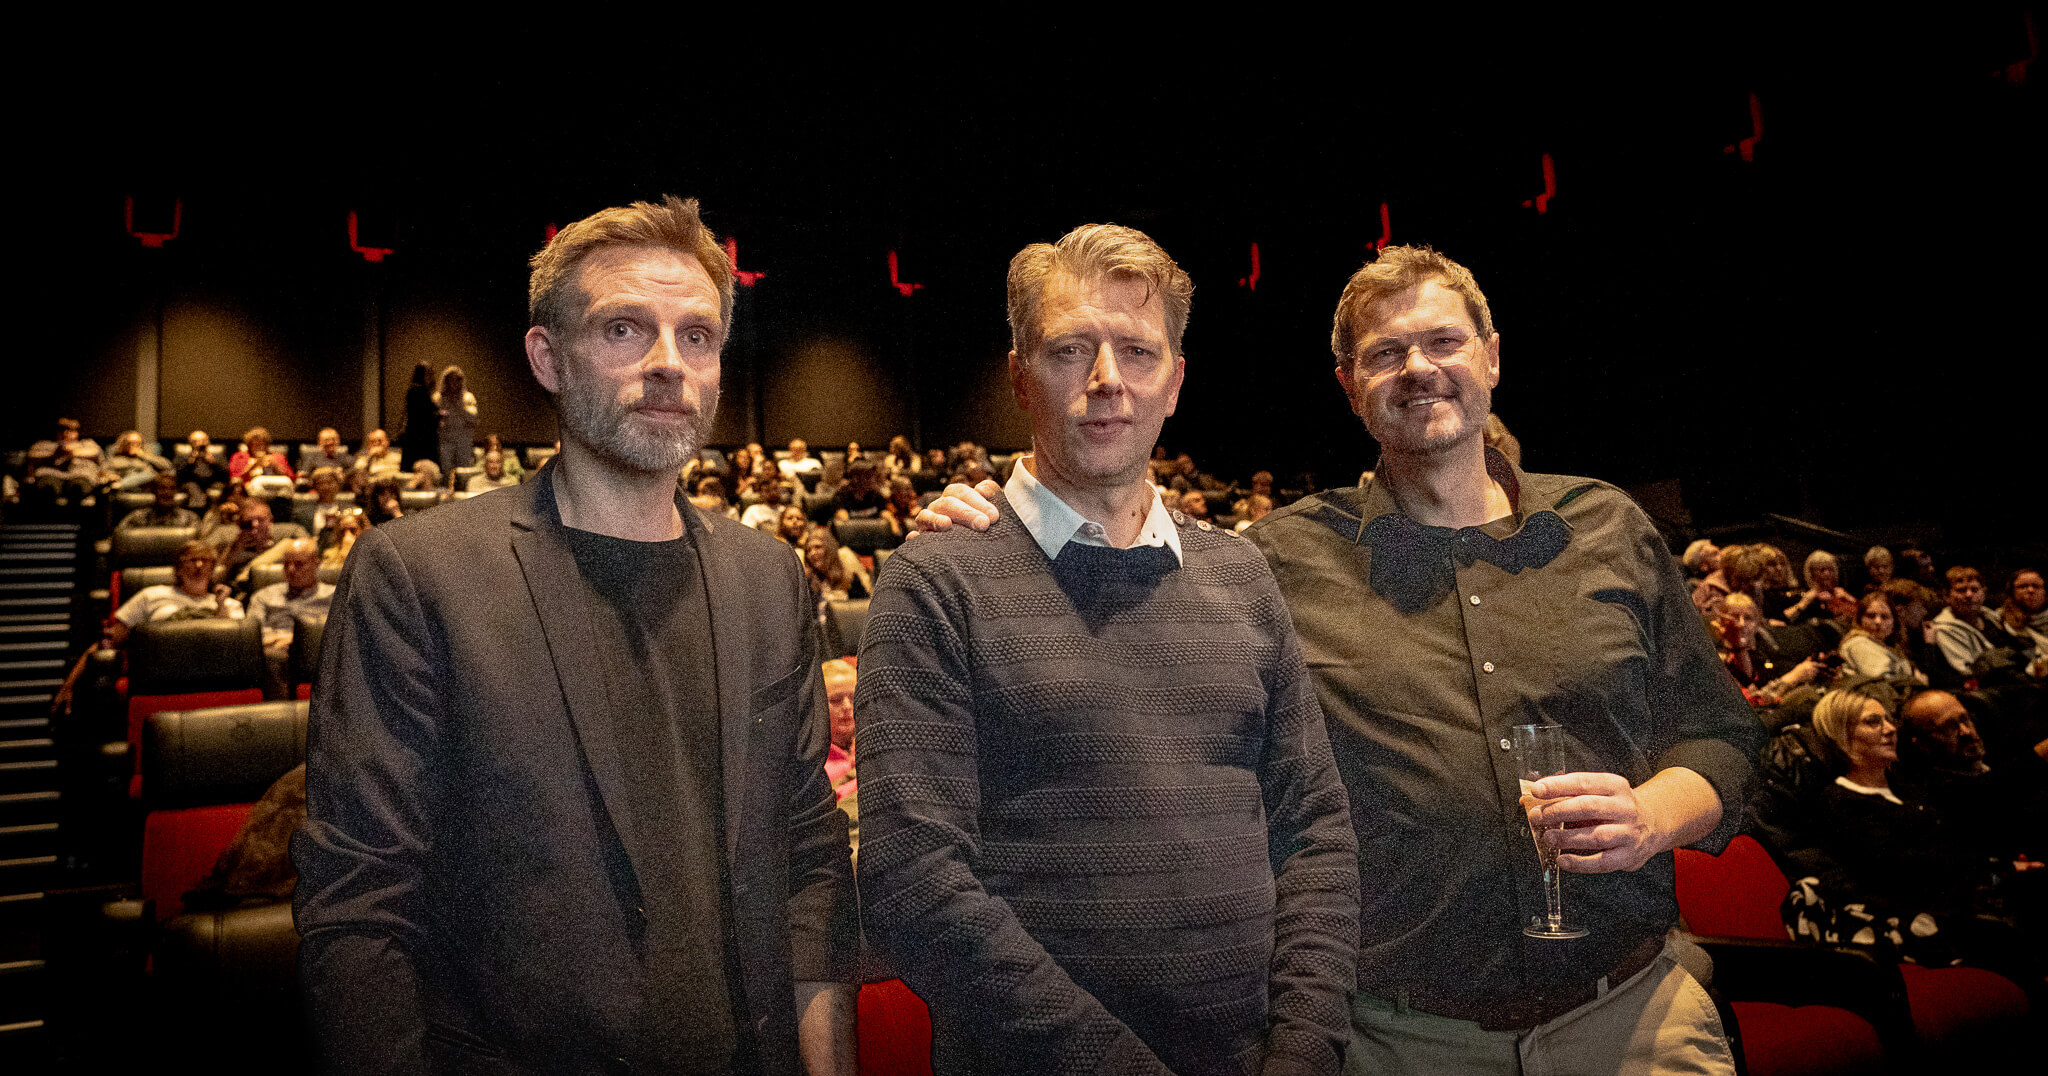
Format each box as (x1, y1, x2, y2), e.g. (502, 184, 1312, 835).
(1260, 592, 1360, 1076)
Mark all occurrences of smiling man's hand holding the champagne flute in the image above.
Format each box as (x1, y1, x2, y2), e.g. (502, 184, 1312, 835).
(1524, 767, 1720, 875)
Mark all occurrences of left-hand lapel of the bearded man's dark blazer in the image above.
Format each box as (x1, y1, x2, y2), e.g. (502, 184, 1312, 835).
(512, 467, 645, 877)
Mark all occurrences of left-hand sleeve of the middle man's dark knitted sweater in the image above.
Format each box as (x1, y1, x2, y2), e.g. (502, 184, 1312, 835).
(854, 539, 1165, 1074)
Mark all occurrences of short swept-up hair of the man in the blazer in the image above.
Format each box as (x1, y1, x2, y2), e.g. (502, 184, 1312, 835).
(526, 195, 733, 332)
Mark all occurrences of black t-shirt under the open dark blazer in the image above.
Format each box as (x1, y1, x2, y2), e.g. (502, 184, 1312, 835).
(567, 527, 739, 1072)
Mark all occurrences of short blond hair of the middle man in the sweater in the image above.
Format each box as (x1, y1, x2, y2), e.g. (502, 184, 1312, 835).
(1010, 223, 1194, 361)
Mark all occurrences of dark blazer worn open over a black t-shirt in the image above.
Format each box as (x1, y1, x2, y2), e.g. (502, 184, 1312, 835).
(293, 469, 854, 1074)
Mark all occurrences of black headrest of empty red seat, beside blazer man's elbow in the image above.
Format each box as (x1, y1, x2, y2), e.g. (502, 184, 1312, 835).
(141, 703, 305, 810)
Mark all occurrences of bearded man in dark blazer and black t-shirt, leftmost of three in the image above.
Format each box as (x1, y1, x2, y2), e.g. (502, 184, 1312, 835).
(293, 197, 854, 1076)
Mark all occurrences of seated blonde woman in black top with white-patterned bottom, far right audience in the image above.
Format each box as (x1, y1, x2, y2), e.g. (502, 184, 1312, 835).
(1757, 685, 1989, 965)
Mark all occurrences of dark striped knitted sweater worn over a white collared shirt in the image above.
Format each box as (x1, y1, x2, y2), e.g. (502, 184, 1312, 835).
(856, 508, 1358, 1074)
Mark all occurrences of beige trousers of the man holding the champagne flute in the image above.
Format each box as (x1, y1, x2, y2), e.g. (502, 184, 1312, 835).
(1343, 941, 1735, 1076)
